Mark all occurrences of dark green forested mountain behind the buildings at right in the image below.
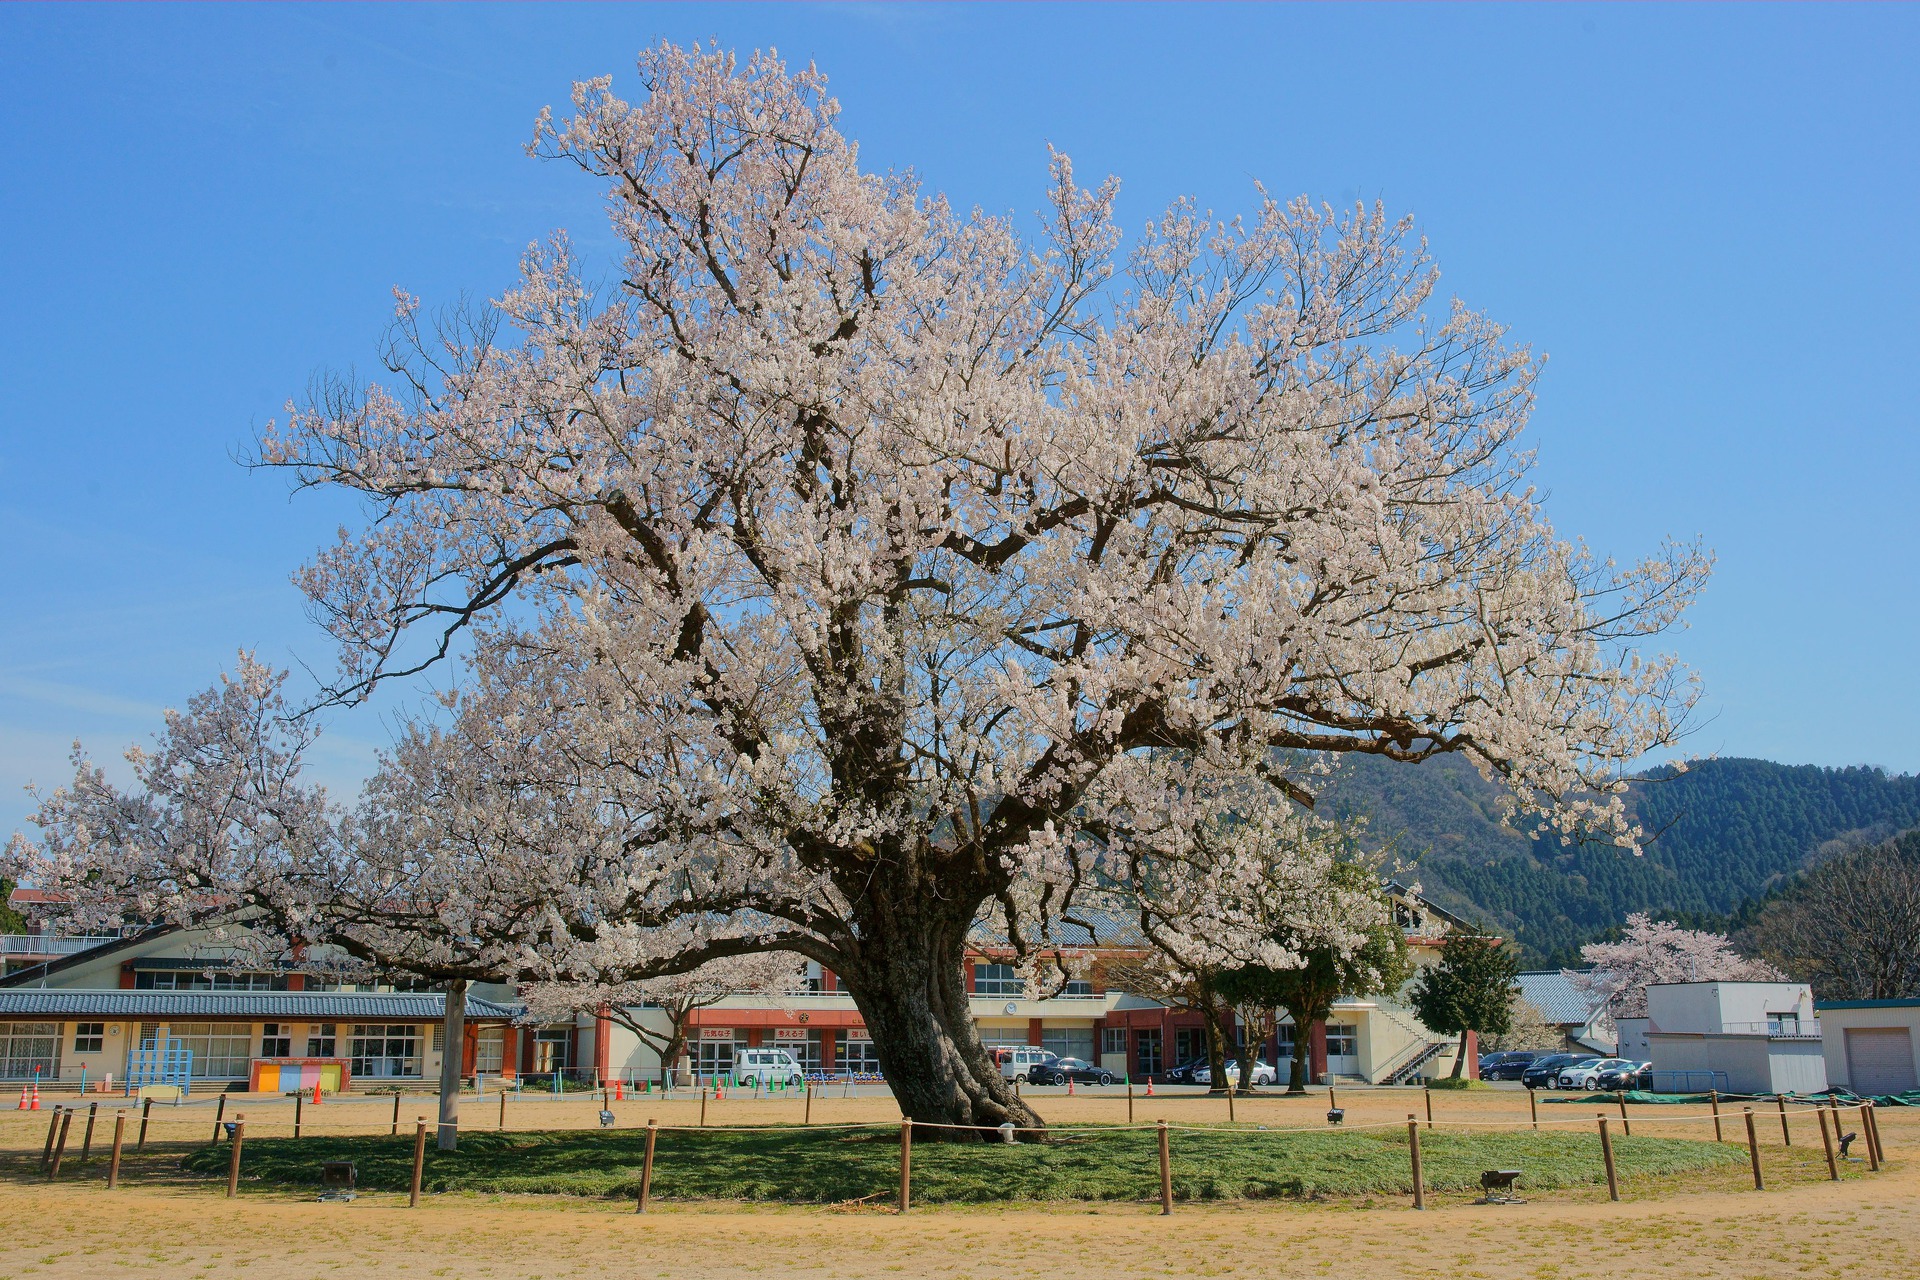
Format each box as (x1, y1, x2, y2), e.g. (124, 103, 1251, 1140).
(1321, 756, 1920, 965)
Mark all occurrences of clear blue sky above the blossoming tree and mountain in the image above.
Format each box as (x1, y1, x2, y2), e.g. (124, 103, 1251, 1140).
(0, 4, 1920, 833)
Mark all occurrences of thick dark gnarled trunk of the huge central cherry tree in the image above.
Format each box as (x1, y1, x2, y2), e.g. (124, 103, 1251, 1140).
(839, 900, 1044, 1140)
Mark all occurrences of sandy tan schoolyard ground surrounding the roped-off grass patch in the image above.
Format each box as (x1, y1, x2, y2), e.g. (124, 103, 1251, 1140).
(0, 1090, 1920, 1280)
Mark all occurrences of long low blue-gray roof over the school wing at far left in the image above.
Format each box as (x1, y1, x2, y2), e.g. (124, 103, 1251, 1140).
(0, 988, 518, 1023)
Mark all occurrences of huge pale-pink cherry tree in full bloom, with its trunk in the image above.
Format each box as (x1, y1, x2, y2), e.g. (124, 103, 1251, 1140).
(15, 44, 1707, 1126)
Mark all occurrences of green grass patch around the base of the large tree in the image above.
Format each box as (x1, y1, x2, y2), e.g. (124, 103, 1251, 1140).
(184, 1126, 1745, 1203)
